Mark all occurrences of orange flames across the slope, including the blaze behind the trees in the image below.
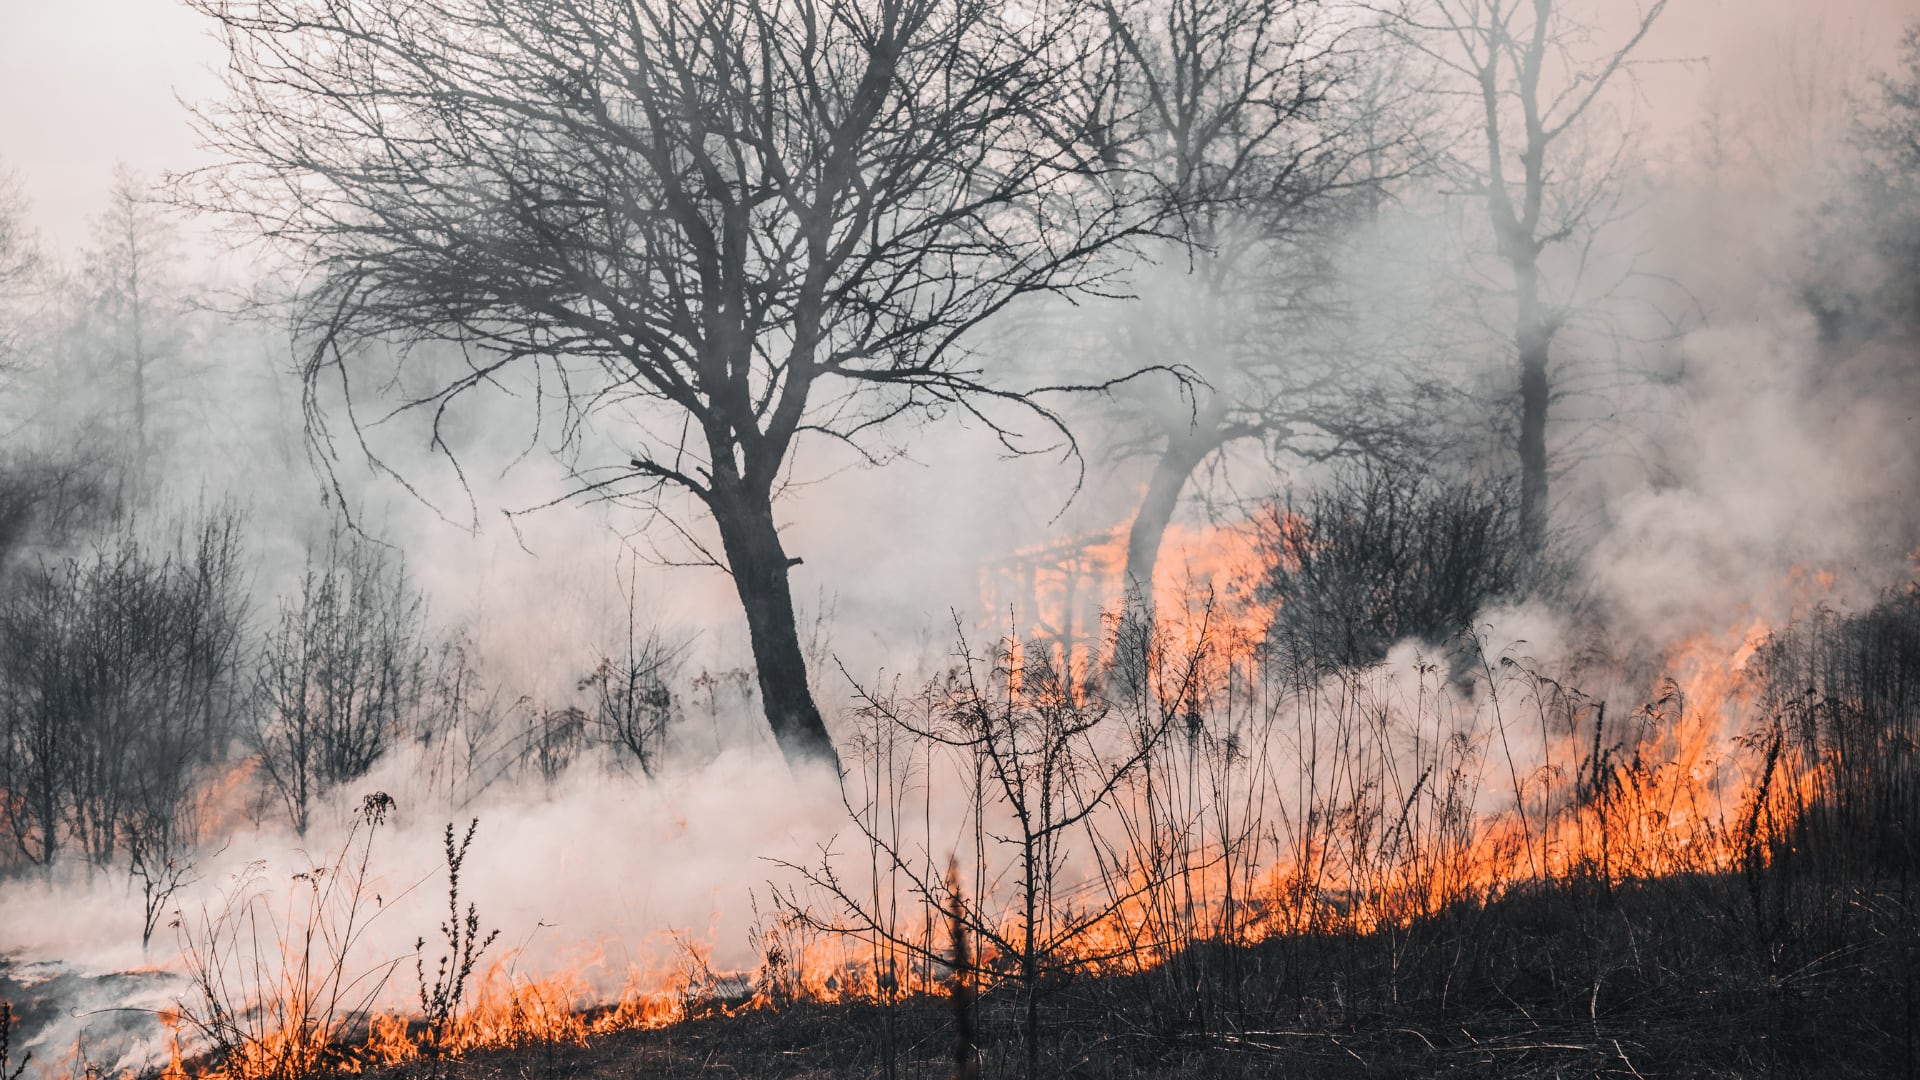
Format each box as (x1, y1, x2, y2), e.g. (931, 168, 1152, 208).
(145, 523, 1873, 1080)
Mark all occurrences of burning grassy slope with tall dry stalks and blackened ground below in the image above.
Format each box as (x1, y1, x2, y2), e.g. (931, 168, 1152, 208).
(7, 503, 1920, 1080)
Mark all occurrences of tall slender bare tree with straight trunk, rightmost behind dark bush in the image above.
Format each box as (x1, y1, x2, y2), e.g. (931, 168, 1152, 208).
(1382, 0, 1667, 550)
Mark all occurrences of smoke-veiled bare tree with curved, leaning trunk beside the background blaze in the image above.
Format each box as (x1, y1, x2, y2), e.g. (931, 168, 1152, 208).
(1100, 0, 1404, 611)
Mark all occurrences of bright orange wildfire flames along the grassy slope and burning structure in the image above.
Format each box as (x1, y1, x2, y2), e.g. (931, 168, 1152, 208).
(127, 527, 1866, 1080)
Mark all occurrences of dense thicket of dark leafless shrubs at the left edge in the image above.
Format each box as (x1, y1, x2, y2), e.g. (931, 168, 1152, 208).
(0, 513, 246, 876)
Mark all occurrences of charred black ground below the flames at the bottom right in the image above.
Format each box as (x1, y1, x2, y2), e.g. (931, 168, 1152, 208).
(349, 878, 1907, 1080)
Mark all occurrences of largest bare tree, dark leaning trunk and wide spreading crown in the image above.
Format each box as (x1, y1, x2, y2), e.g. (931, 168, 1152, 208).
(192, 0, 1159, 761)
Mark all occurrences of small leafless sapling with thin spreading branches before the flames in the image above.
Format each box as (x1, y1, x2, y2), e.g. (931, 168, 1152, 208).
(776, 626, 1206, 1078)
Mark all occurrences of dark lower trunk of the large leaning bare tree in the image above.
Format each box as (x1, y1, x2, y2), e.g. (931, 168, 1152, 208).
(712, 484, 839, 773)
